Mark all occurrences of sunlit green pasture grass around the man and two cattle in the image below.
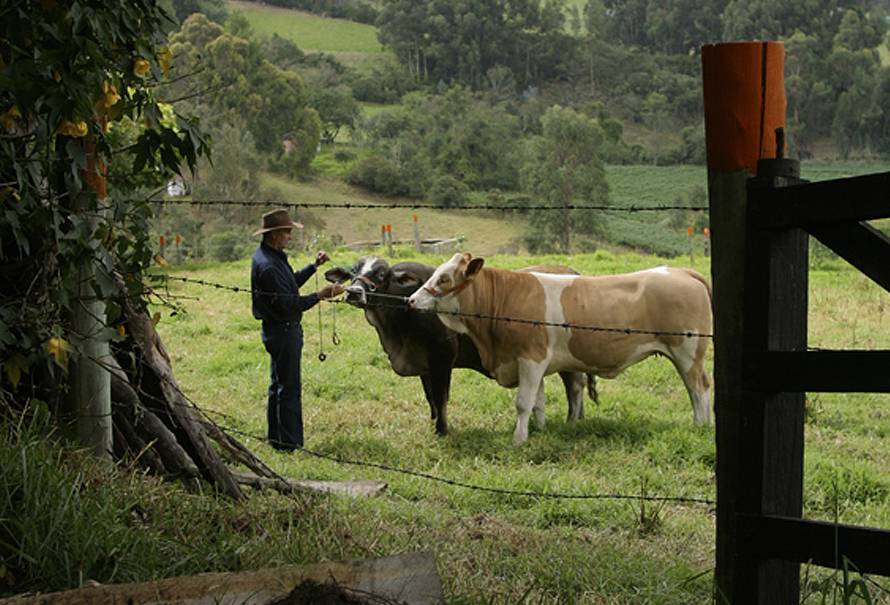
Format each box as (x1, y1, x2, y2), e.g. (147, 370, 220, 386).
(158, 247, 890, 605)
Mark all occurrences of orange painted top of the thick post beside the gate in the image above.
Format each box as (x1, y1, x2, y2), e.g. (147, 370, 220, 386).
(702, 42, 786, 175)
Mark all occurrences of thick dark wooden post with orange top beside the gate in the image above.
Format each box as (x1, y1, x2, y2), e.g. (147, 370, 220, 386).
(702, 42, 803, 604)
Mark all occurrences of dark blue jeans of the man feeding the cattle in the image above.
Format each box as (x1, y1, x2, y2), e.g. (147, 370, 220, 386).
(263, 321, 303, 450)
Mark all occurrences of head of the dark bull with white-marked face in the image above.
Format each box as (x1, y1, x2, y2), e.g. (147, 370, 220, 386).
(325, 256, 431, 309)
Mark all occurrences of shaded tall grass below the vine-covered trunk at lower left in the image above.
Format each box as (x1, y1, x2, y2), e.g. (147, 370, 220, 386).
(0, 407, 359, 596)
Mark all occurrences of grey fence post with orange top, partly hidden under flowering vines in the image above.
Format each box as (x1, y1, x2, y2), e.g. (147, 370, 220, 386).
(71, 126, 113, 459)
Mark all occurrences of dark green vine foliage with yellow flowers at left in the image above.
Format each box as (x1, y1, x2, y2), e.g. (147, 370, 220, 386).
(0, 0, 209, 406)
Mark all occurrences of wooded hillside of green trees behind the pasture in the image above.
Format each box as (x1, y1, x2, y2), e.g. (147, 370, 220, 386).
(151, 0, 890, 249)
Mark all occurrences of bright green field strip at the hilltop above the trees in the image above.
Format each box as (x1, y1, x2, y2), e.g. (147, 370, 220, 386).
(228, 0, 384, 64)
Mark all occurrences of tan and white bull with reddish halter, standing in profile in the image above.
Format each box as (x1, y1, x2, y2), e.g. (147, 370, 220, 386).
(408, 253, 712, 445)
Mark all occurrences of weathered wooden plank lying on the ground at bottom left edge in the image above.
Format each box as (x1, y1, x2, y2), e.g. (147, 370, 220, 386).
(0, 552, 442, 605)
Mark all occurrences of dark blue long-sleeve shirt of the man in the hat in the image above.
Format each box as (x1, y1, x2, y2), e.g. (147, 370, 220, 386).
(250, 244, 319, 323)
